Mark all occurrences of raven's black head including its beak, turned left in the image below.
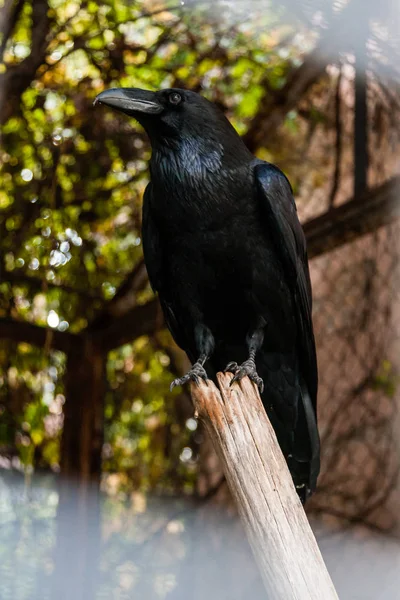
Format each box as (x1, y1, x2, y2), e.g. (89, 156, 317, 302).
(94, 88, 251, 162)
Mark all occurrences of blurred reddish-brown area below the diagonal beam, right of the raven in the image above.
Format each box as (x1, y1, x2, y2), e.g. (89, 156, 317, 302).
(309, 223, 400, 531)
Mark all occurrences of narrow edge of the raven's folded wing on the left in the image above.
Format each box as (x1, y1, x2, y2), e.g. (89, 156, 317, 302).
(142, 183, 192, 358)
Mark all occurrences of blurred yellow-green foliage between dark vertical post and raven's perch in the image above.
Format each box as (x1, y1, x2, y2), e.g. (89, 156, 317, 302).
(104, 338, 196, 491)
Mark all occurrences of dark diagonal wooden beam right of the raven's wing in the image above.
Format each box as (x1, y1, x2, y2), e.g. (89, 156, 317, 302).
(303, 177, 400, 258)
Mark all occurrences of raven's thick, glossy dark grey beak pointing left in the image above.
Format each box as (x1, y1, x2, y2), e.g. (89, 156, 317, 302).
(93, 88, 164, 115)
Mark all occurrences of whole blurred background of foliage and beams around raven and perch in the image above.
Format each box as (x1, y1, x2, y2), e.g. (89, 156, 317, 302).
(0, 0, 400, 600)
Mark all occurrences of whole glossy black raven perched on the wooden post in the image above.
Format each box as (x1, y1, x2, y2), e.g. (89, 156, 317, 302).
(95, 88, 319, 501)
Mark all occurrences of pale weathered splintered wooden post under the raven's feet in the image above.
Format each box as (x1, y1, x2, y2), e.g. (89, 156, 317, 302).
(191, 373, 337, 600)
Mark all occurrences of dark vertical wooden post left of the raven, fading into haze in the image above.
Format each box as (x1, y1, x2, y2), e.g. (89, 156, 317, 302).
(53, 336, 107, 600)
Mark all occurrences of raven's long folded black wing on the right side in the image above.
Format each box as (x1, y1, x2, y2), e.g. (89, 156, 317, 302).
(254, 161, 319, 487)
